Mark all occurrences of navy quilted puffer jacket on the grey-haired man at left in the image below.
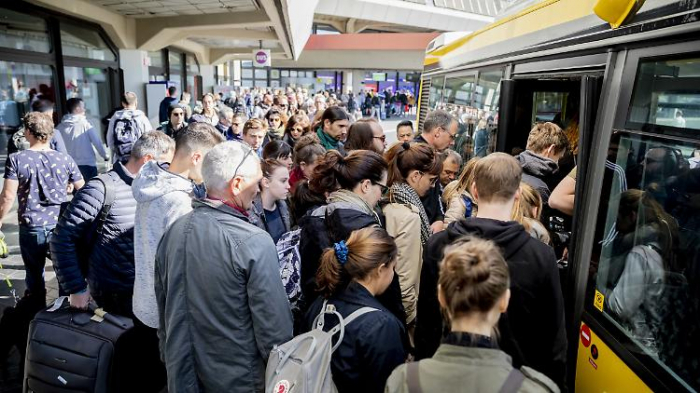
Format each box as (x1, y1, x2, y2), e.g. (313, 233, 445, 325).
(50, 163, 136, 295)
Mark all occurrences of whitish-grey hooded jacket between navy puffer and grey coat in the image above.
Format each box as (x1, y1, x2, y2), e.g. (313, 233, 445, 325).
(131, 161, 194, 329)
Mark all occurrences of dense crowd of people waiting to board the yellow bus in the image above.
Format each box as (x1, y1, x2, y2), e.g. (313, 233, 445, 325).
(0, 82, 696, 392)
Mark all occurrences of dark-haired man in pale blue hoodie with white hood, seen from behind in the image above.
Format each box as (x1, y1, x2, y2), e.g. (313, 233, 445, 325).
(56, 98, 108, 181)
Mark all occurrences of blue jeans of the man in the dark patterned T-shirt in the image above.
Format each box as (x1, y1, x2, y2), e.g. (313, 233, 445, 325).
(19, 225, 55, 295)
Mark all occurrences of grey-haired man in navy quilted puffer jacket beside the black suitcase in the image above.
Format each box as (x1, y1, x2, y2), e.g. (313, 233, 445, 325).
(50, 131, 175, 391)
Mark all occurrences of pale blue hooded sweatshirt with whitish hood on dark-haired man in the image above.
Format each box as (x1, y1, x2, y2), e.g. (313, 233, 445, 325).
(56, 115, 107, 166)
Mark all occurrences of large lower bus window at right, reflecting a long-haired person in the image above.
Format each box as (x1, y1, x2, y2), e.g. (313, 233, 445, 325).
(589, 131, 700, 390)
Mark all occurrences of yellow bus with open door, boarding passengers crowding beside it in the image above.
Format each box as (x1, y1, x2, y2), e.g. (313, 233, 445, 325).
(417, 0, 700, 392)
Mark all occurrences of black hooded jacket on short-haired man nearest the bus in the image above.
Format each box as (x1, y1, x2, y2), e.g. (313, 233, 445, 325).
(416, 217, 567, 387)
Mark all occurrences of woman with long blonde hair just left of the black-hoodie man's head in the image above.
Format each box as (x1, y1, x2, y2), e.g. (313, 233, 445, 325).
(442, 157, 479, 225)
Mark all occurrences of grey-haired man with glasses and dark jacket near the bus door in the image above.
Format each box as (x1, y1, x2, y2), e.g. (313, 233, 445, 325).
(414, 109, 458, 233)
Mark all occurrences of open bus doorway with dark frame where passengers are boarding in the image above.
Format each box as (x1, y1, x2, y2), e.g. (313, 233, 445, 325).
(499, 55, 607, 284)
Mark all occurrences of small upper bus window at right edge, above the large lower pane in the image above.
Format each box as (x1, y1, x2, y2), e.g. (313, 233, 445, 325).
(626, 58, 700, 130)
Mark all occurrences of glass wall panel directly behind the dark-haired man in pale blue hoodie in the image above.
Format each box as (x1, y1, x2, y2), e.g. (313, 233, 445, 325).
(63, 67, 111, 139)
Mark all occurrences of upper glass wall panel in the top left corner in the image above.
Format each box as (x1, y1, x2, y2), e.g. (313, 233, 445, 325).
(0, 8, 51, 53)
